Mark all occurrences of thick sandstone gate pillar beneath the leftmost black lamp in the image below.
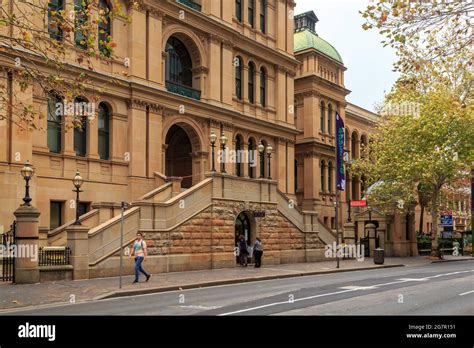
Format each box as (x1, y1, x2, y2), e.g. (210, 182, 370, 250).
(13, 206, 40, 284)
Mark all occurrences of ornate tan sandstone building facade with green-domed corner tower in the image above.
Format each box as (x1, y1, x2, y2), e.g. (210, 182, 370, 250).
(0, 0, 422, 278)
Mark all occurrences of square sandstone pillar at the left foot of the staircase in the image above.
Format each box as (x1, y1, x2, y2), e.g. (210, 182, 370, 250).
(66, 225, 89, 280)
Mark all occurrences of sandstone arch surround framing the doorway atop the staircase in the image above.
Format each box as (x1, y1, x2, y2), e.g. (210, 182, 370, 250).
(162, 117, 209, 187)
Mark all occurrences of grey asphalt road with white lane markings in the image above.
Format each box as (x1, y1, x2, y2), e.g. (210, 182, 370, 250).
(1, 261, 474, 315)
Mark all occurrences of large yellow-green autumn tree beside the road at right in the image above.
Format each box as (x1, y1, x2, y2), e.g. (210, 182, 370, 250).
(358, 0, 474, 255)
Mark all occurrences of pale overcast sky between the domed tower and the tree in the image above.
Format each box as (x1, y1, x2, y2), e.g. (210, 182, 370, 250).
(295, 0, 397, 111)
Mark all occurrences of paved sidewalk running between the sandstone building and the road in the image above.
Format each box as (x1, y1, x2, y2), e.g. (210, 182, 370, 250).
(0, 256, 474, 313)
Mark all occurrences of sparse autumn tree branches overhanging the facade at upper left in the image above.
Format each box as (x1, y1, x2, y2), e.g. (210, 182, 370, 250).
(0, 0, 134, 130)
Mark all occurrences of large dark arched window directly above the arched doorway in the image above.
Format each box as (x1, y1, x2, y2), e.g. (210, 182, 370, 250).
(166, 36, 193, 88)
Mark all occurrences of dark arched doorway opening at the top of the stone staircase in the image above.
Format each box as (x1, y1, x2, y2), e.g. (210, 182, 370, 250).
(165, 125, 193, 188)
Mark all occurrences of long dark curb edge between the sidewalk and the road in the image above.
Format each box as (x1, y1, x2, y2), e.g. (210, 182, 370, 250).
(93, 264, 405, 301)
